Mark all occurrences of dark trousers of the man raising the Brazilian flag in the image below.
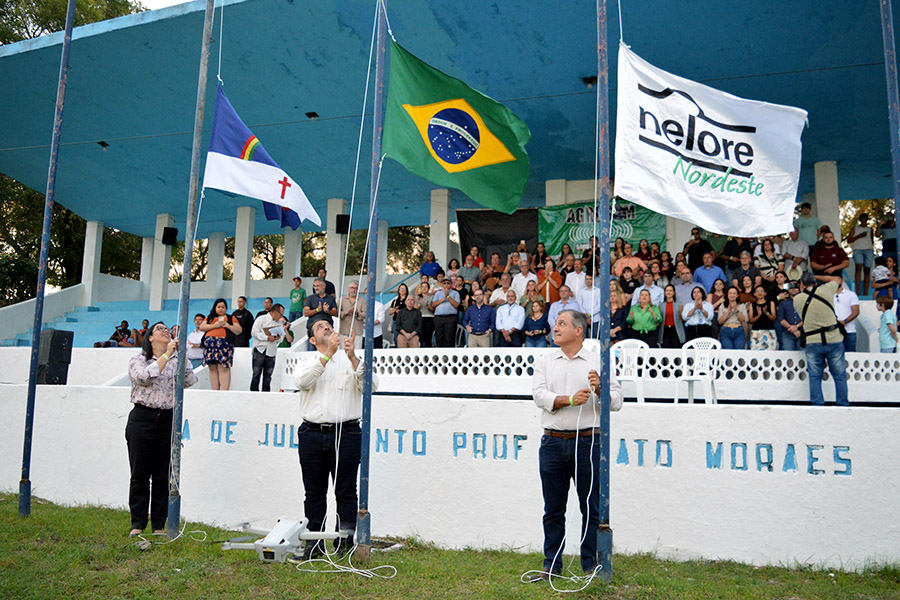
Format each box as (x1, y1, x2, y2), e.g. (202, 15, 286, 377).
(297, 421, 361, 531)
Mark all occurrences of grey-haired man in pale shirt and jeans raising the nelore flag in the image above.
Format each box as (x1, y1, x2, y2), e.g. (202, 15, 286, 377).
(532, 310, 622, 577)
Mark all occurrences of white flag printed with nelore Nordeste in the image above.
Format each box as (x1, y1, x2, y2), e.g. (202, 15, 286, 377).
(615, 44, 806, 237)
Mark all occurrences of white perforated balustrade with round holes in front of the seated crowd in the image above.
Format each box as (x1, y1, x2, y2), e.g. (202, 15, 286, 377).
(281, 347, 900, 403)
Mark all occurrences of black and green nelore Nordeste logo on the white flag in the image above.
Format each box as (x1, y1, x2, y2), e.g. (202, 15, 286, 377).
(638, 83, 763, 196)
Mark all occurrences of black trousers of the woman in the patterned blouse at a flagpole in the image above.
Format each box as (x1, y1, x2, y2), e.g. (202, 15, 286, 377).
(125, 404, 172, 529)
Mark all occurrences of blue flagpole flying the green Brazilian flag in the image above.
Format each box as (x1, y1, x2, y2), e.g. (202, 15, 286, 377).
(356, 0, 387, 561)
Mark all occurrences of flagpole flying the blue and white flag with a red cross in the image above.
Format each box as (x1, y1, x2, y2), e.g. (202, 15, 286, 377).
(166, 0, 215, 539)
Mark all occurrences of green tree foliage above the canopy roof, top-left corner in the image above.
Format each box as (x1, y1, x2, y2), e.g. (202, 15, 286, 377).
(0, 0, 145, 45)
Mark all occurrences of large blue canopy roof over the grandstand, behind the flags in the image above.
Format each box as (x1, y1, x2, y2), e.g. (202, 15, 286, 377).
(0, 0, 898, 238)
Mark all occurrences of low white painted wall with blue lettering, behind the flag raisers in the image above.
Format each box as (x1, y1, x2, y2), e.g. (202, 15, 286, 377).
(0, 386, 900, 569)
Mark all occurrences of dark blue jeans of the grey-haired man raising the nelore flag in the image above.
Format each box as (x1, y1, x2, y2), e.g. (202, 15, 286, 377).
(538, 435, 600, 573)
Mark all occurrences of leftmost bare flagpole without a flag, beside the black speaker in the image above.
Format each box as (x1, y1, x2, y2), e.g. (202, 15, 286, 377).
(19, 0, 75, 517)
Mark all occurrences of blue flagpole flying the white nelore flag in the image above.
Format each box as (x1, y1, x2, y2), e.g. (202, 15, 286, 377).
(594, 0, 612, 581)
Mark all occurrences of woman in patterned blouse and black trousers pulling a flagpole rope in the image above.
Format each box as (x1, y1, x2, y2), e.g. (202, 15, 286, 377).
(125, 321, 197, 536)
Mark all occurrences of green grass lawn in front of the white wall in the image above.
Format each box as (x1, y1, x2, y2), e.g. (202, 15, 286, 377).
(0, 494, 900, 600)
